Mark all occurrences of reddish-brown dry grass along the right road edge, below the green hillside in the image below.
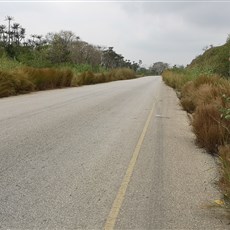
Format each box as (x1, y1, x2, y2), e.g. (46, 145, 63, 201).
(163, 71, 230, 211)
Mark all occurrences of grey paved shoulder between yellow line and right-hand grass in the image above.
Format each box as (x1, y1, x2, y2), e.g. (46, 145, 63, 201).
(115, 79, 229, 229)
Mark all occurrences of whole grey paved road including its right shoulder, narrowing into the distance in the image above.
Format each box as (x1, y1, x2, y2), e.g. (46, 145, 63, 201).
(0, 77, 229, 229)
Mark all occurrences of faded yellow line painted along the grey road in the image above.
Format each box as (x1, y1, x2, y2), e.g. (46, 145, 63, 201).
(104, 99, 155, 230)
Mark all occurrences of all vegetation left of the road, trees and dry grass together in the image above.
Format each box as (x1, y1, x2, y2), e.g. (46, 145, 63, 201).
(0, 16, 155, 97)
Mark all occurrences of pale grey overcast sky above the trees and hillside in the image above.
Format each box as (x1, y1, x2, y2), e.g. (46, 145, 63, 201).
(0, 0, 230, 67)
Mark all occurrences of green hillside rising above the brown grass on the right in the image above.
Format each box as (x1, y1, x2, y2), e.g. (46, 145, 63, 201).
(188, 42, 230, 77)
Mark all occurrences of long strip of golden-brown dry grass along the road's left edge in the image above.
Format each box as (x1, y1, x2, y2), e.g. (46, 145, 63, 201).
(0, 67, 136, 97)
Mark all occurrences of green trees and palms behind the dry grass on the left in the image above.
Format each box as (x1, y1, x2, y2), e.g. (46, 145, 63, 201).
(0, 16, 146, 71)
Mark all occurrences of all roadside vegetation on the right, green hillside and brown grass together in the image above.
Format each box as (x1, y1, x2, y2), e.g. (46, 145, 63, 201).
(163, 36, 230, 215)
